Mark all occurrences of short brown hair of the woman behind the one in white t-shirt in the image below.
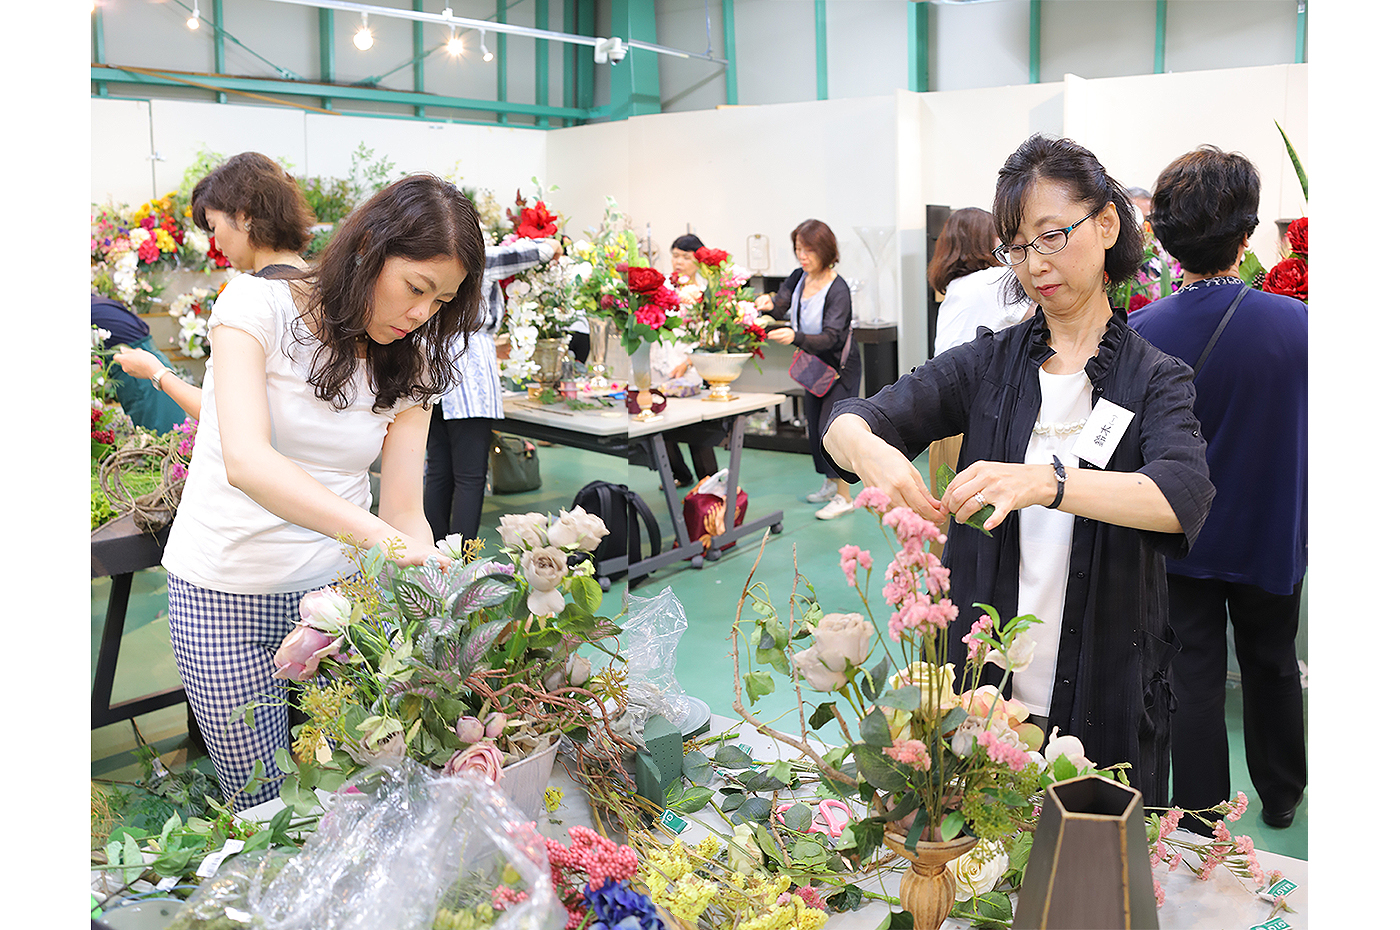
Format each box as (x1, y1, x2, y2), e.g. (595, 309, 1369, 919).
(189, 151, 316, 252)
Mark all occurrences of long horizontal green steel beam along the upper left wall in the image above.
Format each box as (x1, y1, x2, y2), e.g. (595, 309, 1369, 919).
(91, 64, 602, 119)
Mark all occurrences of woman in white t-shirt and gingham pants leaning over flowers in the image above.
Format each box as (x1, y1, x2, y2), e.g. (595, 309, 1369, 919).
(162, 175, 484, 810)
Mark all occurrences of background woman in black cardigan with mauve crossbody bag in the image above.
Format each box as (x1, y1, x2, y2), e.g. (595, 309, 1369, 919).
(755, 220, 861, 520)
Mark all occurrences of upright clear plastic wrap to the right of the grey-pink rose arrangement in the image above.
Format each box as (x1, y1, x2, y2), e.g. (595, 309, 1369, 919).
(622, 585, 693, 727)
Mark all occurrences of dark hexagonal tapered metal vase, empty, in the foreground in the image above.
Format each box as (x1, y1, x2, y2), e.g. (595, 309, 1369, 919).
(1011, 775, 1158, 930)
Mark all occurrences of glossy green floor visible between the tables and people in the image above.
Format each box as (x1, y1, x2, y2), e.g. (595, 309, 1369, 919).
(92, 447, 1308, 859)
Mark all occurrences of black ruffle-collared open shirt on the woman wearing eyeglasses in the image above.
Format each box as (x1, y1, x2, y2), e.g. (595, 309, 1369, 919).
(832, 310, 1215, 807)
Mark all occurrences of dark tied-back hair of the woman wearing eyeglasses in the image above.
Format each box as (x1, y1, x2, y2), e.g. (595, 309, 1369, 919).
(991, 133, 1142, 303)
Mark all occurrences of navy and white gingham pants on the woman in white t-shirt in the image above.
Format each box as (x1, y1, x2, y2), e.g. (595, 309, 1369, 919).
(167, 574, 315, 811)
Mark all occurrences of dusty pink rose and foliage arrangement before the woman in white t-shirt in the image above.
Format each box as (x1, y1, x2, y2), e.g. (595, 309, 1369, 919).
(259, 507, 626, 812)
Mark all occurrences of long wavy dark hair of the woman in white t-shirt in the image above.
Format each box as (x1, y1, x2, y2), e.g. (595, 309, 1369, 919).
(270, 174, 486, 410)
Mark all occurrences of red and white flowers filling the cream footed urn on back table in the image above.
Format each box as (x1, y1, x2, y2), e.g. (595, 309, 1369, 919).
(672, 247, 767, 359)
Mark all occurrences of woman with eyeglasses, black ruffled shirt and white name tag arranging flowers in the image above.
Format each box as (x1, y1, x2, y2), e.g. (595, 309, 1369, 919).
(825, 136, 1215, 805)
